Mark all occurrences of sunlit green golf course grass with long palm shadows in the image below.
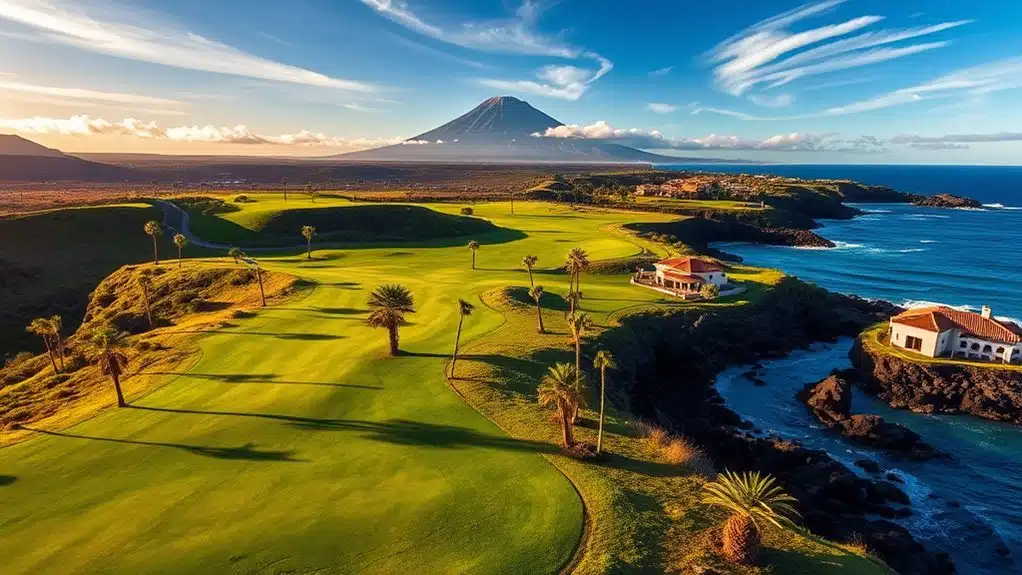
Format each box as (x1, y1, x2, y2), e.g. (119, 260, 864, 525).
(0, 200, 882, 574)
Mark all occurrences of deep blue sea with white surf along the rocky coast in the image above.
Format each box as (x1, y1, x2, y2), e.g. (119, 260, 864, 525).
(672, 165, 1022, 575)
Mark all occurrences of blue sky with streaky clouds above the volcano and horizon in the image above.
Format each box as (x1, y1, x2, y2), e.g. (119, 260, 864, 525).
(0, 0, 1022, 164)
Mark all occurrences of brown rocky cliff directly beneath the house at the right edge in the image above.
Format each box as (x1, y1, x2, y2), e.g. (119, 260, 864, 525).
(849, 336, 1022, 425)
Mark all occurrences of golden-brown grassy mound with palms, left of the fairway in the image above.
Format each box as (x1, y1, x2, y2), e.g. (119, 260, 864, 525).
(0, 265, 295, 443)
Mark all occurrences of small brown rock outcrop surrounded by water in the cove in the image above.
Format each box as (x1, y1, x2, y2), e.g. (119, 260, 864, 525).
(797, 371, 948, 461)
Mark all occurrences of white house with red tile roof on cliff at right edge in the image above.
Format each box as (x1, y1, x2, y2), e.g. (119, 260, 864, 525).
(890, 305, 1022, 364)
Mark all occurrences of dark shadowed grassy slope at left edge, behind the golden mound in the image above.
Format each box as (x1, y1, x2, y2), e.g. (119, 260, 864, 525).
(0, 204, 181, 358)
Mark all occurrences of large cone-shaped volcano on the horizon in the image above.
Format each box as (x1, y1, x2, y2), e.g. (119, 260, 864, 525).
(331, 96, 686, 163)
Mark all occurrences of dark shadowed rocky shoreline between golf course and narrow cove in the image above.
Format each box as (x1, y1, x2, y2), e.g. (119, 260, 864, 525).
(598, 278, 955, 575)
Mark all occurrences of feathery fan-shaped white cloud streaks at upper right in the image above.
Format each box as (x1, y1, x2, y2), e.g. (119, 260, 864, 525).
(708, 0, 971, 96)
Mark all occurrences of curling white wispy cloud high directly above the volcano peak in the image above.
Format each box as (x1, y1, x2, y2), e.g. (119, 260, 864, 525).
(361, 0, 614, 100)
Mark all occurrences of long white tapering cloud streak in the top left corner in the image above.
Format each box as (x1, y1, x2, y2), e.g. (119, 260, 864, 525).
(0, 0, 376, 92)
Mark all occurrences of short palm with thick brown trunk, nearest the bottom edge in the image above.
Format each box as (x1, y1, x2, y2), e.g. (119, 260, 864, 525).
(702, 471, 799, 564)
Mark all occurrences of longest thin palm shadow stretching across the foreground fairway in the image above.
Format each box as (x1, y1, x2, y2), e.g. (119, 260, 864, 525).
(129, 405, 560, 453)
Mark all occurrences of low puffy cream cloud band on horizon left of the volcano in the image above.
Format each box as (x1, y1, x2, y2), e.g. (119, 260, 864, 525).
(0, 114, 429, 151)
